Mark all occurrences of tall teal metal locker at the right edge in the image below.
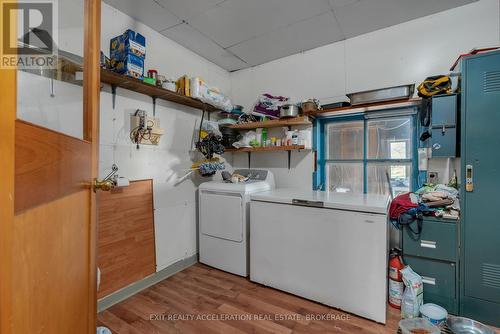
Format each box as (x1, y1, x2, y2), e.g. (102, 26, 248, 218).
(460, 51, 500, 326)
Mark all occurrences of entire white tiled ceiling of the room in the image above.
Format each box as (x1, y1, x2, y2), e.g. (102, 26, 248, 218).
(100, 0, 478, 71)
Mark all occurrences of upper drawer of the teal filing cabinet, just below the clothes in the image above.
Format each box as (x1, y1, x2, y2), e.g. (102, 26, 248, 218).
(403, 219, 458, 261)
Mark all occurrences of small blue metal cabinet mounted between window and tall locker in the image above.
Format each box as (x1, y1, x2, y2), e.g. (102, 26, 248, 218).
(431, 94, 460, 158)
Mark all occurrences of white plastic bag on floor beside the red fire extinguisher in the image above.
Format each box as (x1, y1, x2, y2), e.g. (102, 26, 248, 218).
(401, 266, 424, 318)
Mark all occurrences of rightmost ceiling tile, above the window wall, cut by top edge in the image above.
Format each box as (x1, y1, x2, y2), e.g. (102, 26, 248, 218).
(335, 0, 478, 38)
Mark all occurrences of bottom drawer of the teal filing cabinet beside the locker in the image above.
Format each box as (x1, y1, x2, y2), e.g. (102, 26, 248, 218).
(404, 256, 457, 308)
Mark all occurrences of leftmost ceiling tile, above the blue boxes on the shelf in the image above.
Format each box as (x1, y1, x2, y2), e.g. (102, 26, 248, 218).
(103, 0, 181, 31)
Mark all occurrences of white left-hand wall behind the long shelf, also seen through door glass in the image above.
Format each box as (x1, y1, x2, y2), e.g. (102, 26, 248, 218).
(18, 0, 231, 270)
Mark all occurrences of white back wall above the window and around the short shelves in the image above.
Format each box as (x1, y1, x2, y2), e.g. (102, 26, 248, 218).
(231, 0, 500, 187)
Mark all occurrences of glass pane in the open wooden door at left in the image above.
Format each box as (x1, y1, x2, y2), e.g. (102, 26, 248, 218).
(17, 0, 84, 139)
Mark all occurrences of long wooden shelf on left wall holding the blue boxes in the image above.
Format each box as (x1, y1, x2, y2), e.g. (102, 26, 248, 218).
(101, 69, 219, 112)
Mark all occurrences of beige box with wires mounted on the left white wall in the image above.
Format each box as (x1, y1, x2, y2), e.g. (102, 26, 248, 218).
(130, 113, 165, 145)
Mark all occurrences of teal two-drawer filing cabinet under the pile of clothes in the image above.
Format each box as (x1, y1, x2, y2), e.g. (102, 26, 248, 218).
(403, 217, 460, 314)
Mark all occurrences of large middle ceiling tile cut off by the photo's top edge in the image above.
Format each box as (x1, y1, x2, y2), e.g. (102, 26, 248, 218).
(189, 0, 330, 47)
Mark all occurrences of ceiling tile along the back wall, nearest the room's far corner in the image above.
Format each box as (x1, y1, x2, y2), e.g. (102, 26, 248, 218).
(228, 12, 343, 65)
